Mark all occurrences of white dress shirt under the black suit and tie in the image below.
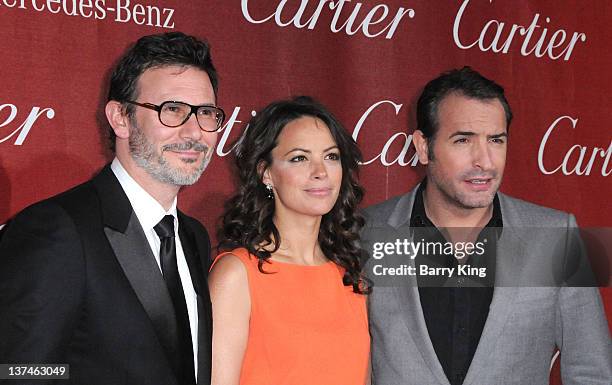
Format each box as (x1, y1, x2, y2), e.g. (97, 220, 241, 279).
(111, 158, 198, 380)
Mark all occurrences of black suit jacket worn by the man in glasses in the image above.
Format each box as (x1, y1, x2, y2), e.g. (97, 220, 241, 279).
(0, 166, 212, 385)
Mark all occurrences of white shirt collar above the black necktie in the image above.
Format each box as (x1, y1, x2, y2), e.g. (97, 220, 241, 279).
(111, 158, 178, 231)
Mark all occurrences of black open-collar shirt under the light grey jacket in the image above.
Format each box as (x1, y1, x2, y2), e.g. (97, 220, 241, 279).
(410, 180, 503, 385)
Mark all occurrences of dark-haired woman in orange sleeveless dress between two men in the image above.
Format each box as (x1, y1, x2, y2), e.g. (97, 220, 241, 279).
(209, 97, 370, 385)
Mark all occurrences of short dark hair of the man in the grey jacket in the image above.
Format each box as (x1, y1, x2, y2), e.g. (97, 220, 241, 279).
(417, 66, 512, 146)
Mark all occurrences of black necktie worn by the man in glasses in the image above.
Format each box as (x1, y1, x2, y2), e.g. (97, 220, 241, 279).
(153, 215, 195, 385)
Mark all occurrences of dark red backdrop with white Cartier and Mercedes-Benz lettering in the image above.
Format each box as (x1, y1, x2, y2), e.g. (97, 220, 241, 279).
(0, 0, 612, 380)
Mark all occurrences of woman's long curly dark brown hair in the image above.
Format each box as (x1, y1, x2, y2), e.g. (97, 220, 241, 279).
(218, 96, 370, 294)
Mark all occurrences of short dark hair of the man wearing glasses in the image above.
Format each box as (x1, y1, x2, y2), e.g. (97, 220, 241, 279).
(107, 32, 218, 151)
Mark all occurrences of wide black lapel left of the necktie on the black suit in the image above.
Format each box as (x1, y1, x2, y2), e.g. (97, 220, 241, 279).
(93, 166, 179, 378)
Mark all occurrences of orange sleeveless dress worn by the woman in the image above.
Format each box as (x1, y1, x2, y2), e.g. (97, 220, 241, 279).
(217, 248, 370, 385)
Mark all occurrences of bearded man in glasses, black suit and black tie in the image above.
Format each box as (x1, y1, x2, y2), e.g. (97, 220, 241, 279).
(0, 32, 224, 385)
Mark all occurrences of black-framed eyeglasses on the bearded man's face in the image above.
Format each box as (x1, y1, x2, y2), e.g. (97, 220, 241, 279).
(127, 100, 225, 132)
